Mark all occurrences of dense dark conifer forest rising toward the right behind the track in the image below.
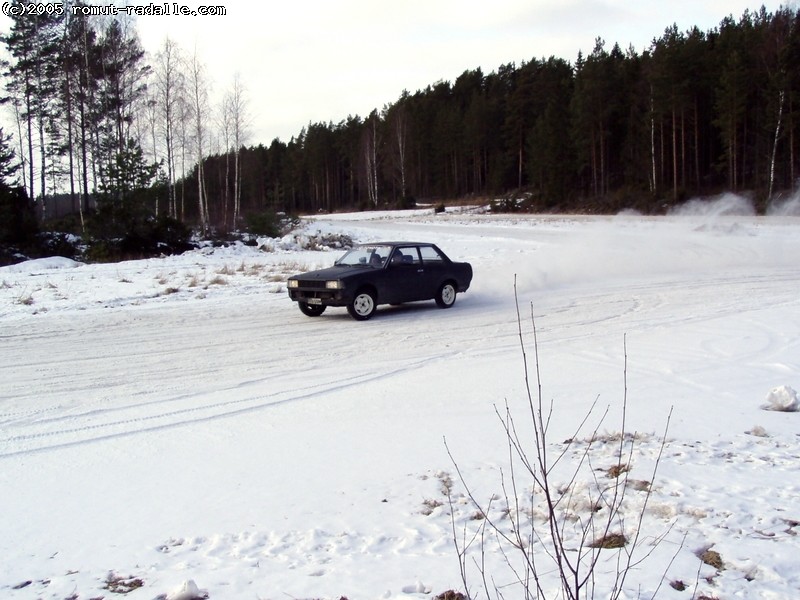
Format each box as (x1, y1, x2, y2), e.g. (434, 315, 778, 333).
(238, 8, 800, 213)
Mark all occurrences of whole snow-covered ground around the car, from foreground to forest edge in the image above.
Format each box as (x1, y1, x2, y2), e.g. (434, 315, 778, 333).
(0, 203, 800, 600)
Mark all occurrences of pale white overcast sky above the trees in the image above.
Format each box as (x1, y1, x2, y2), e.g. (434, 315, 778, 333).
(0, 0, 797, 144)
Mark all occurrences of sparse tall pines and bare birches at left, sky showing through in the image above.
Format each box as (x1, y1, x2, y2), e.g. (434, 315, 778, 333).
(0, 0, 246, 240)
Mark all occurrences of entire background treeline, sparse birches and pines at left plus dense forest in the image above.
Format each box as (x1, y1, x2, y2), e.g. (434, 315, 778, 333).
(2, 0, 800, 248)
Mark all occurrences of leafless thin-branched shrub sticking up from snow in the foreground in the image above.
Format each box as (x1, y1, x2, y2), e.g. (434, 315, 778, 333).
(445, 282, 682, 600)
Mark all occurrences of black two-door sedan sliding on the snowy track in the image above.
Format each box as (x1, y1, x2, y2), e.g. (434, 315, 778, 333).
(288, 242, 472, 321)
